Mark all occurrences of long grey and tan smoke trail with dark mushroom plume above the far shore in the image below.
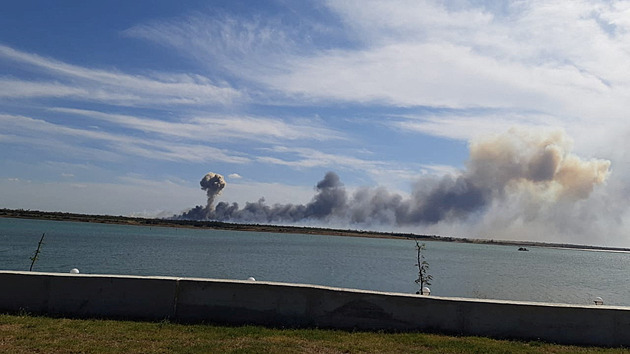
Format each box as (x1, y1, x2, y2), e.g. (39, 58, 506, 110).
(178, 129, 610, 242)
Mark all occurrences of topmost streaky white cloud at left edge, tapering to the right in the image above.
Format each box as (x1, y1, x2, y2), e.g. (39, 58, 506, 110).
(0, 44, 244, 105)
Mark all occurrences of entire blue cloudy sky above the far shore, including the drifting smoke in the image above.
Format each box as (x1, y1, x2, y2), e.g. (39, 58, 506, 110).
(0, 0, 630, 247)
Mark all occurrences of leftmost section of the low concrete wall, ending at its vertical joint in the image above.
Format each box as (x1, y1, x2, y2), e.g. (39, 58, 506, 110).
(0, 272, 177, 320)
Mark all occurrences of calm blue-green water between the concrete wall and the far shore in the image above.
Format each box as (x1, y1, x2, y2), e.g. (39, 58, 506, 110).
(0, 218, 630, 306)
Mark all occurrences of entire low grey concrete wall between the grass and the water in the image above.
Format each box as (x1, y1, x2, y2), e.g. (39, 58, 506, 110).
(0, 271, 630, 346)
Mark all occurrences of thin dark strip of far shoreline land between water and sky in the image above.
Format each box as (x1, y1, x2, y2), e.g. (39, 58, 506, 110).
(0, 209, 630, 252)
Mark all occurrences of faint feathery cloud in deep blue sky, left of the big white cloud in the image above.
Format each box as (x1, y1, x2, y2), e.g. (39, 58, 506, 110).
(123, 11, 333, 77)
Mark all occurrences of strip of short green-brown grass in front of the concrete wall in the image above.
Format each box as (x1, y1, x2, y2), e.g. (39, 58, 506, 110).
(0, 315, 628, 353)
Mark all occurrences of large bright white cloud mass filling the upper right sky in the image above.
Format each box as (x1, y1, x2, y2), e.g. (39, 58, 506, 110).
(252, 1, 630, 159)
